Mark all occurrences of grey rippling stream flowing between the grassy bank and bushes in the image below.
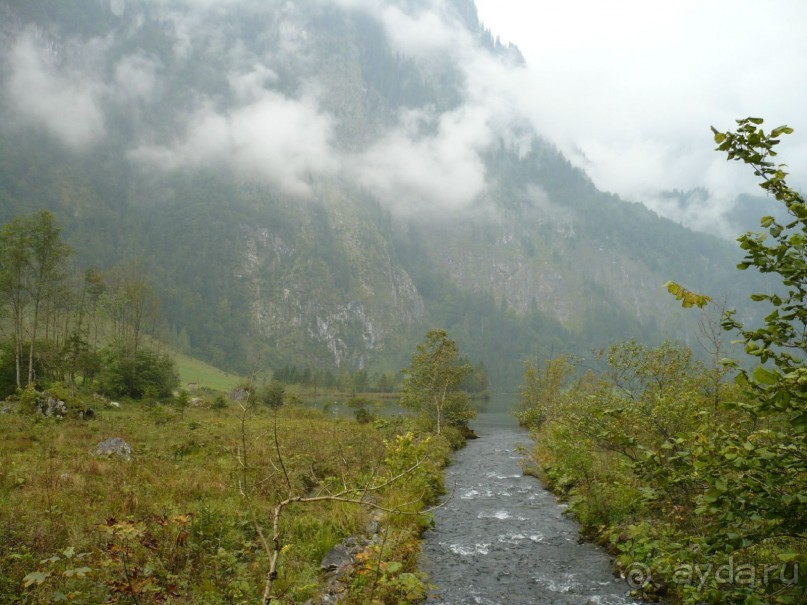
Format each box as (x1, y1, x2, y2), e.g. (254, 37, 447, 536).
(420, 413, 635, 605)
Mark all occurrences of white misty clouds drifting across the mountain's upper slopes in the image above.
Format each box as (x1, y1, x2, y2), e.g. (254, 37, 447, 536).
(6, 0, 530, 216)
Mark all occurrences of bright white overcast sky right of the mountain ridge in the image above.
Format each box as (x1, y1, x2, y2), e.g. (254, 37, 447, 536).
(476, 0, 807, 231)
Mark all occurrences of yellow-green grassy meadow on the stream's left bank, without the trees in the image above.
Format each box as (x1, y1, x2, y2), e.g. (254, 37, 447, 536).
(0, 402, 448, 604)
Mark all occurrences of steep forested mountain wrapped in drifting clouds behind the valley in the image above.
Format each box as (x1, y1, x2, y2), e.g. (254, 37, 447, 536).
(0, 0, 758, 387)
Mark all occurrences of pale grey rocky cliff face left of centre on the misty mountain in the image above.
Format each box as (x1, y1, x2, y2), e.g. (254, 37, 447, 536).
(242, 190, 426, 369)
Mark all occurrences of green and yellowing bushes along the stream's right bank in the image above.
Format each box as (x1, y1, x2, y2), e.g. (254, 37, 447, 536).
(518, 118, 807, 605)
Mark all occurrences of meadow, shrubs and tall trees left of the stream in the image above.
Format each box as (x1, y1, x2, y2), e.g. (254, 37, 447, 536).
(0, 219, 473, 605)
